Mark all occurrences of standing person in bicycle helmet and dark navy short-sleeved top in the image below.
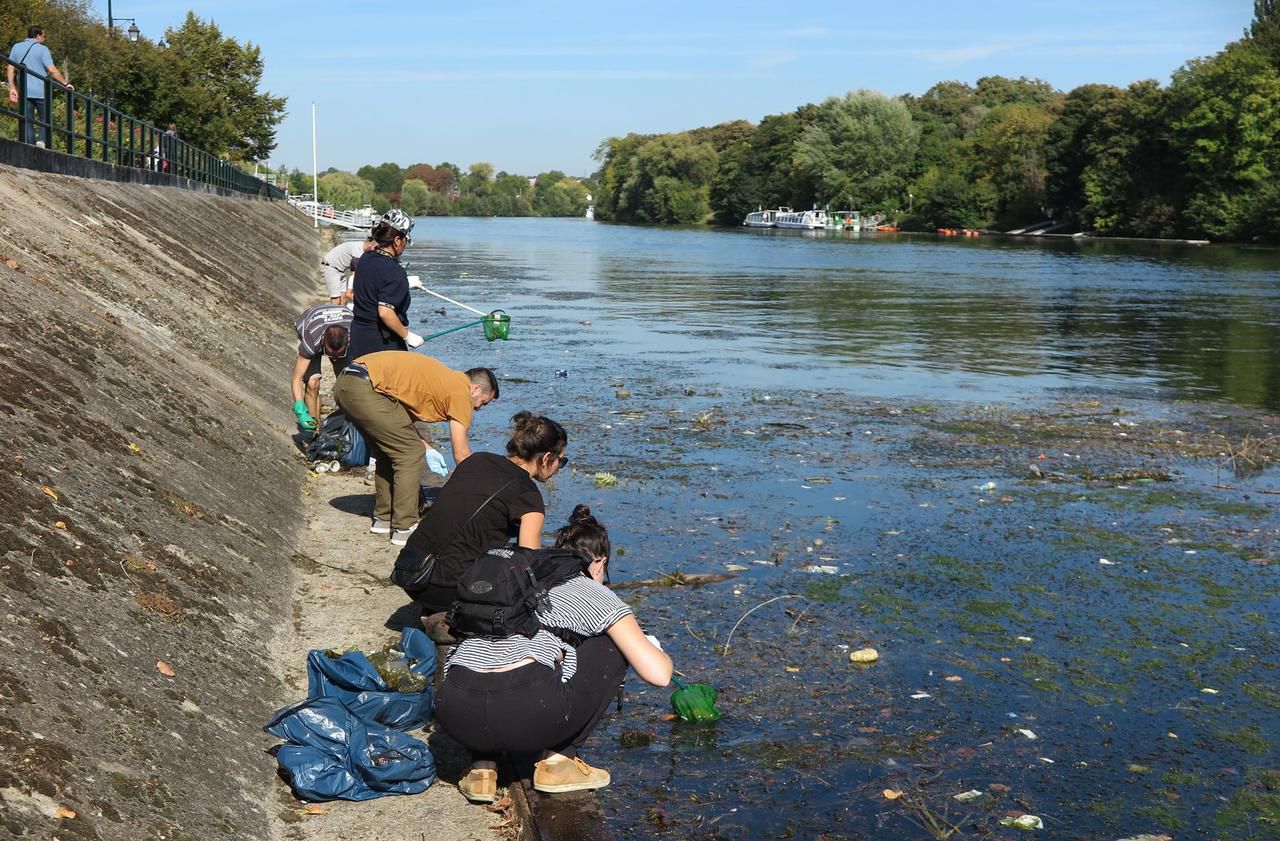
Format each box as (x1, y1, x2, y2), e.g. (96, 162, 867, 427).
(351, 209, 422, 360)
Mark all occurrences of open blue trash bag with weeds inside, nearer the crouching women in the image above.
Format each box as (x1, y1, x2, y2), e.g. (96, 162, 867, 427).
(307, 627, 435, 730)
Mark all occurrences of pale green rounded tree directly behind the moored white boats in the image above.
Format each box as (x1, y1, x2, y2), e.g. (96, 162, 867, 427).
(794, 91, 919, 210)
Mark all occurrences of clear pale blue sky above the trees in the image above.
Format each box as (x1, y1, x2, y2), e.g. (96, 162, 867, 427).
(90, 0, 1253, 175)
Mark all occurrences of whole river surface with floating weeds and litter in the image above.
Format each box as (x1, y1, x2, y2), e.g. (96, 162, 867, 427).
(407, 219, 1280, 841)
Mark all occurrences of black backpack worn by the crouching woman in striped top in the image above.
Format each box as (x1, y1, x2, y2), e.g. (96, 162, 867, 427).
(447, 547, 591, 644)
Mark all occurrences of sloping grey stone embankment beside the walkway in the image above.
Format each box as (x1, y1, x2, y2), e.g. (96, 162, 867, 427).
(0, 166, 319, 841)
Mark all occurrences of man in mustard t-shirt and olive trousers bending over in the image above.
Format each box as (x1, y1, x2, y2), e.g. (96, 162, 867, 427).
(333, 351, 498, 547)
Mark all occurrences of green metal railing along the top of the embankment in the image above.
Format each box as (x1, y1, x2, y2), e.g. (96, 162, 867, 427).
(0, 59, 284, 198)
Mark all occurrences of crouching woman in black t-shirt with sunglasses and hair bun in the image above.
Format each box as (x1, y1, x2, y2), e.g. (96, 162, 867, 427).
(396, 412, 568, 629)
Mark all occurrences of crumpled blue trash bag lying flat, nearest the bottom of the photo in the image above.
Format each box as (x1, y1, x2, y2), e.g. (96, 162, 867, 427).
(266, 698, 435, 803)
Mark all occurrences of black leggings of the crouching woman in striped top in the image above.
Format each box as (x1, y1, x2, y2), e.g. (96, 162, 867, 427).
(435, 635, 627, 758)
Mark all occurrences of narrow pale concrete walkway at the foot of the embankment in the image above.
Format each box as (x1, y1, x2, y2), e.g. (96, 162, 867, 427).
(268, 463, 511, 841)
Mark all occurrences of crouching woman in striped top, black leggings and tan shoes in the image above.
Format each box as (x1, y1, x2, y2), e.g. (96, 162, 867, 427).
(435, 506, 672, 803)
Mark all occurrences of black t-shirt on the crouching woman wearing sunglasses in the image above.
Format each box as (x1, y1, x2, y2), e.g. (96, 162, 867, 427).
(401, 453, 545, 609)
